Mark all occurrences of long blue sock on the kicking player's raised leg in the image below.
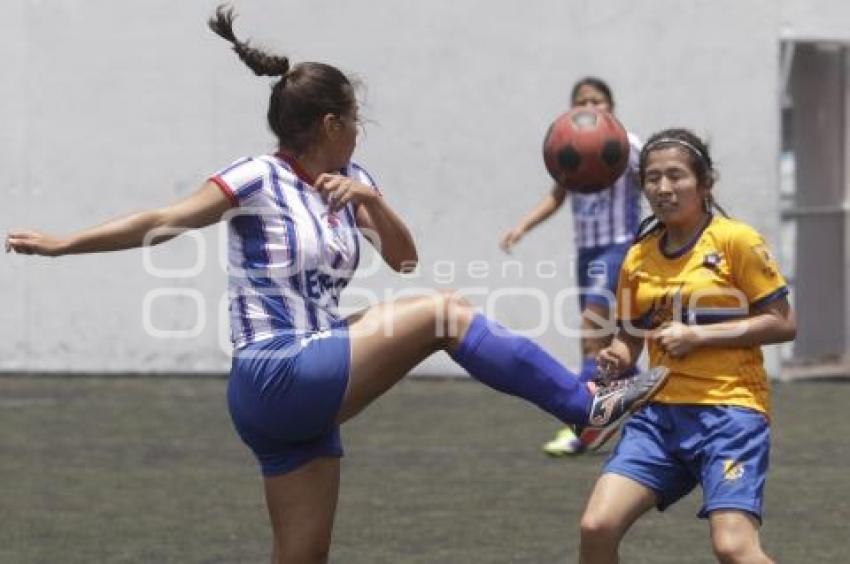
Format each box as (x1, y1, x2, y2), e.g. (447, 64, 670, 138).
(451, 315, 593, 425)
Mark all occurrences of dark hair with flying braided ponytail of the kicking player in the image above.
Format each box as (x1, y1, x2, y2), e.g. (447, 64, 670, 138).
(208, 5, 356, 155)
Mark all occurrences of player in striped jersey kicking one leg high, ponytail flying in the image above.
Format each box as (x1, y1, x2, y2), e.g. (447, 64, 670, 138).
(6, 8, 666, 564)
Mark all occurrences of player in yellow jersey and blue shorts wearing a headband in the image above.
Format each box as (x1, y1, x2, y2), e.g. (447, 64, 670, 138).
(581, 129, 796, 564)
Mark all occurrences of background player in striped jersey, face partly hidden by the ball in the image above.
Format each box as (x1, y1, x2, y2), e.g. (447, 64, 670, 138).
(501, 77, 640, 456)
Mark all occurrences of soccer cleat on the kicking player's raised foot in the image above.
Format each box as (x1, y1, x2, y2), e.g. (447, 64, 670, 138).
(579, 366, 670, 450)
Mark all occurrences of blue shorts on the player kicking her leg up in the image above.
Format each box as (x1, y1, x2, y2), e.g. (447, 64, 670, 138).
(227, 322, 351, 476)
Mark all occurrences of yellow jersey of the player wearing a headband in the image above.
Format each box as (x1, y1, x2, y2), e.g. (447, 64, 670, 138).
(617, 217, 788, 414)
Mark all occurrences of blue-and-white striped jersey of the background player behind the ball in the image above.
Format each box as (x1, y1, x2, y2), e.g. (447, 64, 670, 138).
(569, 133, 641, 249)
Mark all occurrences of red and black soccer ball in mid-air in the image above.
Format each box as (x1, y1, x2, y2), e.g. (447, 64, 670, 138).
(543, 107, 629, 194)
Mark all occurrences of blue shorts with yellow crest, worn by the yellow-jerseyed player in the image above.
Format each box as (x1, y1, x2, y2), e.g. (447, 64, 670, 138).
(603, 403, 770, 520)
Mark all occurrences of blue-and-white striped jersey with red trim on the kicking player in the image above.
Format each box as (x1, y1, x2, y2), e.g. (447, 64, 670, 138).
(210, 155, 377, 349)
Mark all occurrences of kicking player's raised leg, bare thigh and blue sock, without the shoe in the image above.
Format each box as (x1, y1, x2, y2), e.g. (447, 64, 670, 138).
(338, 292, 593, 424)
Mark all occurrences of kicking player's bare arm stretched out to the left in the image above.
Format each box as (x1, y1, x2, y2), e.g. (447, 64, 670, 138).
(6, 181, 232, 256)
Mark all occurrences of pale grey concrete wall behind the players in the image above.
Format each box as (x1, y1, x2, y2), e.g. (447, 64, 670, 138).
(0, 0, 820, 372)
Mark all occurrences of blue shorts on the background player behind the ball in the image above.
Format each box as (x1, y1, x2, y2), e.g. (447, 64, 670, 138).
(576, 243, 632, 311)
